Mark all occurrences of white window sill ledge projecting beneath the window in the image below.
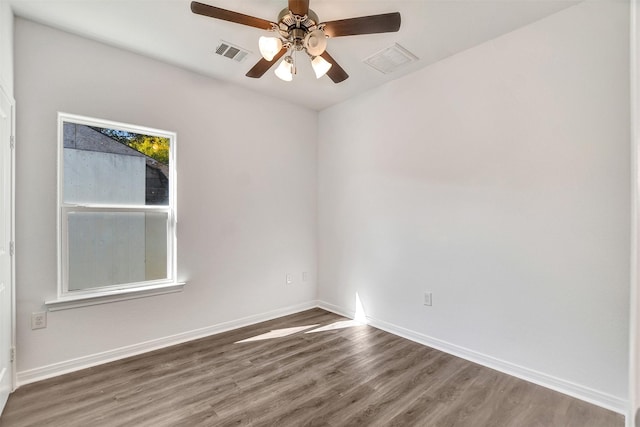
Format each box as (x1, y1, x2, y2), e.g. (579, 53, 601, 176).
(44, 282, 185, 311)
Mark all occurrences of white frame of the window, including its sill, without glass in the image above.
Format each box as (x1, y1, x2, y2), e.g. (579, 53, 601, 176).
(45, 113, 184, 311)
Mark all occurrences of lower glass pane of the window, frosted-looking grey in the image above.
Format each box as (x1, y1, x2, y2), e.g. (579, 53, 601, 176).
(67, 212, 168, 291)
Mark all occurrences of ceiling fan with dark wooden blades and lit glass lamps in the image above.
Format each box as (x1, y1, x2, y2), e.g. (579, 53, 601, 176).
(191, 0, 400, 83)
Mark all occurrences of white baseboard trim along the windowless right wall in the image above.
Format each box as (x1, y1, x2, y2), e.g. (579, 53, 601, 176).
(318, 301, 629, 416)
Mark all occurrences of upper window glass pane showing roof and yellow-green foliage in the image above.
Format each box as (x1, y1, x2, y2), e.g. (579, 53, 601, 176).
(63, 122, 170, 205)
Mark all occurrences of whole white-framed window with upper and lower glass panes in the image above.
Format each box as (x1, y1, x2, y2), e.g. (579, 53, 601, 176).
(47, 113, 177, 308)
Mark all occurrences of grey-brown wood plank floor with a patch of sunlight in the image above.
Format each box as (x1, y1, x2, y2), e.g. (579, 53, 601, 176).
(0, 309, 624, 427)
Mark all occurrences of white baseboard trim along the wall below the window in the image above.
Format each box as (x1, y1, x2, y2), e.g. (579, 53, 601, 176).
(16, 301, 318, 388)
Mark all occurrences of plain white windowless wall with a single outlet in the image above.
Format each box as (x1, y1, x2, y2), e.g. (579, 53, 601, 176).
(318, 2, 630, 412)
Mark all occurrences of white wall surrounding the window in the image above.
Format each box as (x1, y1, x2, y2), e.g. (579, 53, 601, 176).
(15, 19, 317, 380)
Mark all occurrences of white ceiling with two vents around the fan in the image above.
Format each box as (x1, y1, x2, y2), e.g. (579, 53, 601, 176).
(3, 0, 577, 110)
